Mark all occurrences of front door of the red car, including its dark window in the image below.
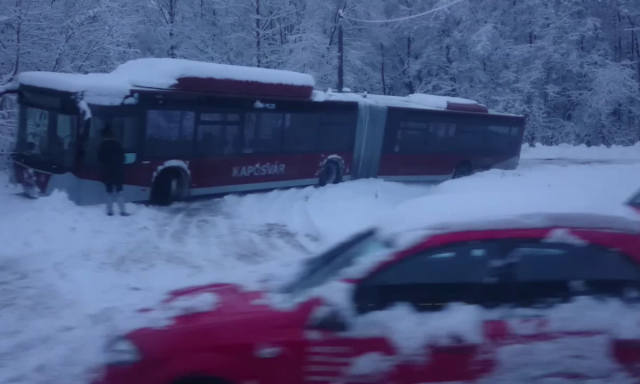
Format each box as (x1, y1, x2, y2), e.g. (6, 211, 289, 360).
(353, 238, 509, 384)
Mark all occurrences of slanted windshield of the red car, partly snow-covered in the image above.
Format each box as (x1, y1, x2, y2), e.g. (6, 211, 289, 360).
(282, 230, 393, 294)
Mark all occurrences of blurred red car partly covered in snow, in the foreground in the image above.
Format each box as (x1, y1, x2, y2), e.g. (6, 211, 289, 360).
(94, 213, 640, 384)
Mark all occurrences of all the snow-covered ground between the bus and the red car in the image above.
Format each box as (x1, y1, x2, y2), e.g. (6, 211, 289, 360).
(0, 146, 640, 384)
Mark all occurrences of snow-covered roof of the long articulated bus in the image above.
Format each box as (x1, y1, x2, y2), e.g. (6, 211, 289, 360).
(18, 58, 516, 116)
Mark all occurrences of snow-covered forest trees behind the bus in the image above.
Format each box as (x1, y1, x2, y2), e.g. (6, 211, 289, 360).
(0, 0, 640, 144)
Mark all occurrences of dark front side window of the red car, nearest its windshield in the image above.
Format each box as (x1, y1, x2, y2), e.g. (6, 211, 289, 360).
(354, 243, 500, 314)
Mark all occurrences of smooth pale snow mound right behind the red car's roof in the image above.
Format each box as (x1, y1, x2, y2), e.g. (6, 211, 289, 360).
(381, 161, 640, 238)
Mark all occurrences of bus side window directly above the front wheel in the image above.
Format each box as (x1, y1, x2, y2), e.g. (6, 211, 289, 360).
(145, 111, 196, 158)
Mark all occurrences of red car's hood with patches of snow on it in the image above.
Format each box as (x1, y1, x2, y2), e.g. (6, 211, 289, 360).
(129, 284, 319, 357)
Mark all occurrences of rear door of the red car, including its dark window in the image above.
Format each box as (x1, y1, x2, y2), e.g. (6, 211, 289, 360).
(494, 241, 640, 382)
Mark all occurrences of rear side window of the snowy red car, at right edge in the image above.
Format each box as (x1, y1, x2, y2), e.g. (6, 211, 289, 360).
(509, 242, 640, 307)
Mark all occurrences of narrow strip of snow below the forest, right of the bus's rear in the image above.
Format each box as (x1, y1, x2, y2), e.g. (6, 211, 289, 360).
(521, 143, 640, 161)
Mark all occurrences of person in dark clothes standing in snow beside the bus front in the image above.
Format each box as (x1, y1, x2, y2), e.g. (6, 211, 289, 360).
(98, 125, 128, 216)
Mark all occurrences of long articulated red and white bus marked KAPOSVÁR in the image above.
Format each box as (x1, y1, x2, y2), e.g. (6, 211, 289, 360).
(1, 59, 525, 205)
